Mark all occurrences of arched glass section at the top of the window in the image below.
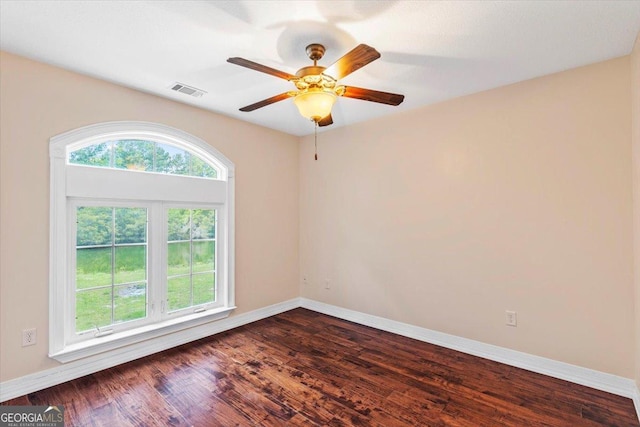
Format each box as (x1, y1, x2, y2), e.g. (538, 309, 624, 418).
(68, 139, 220, 179)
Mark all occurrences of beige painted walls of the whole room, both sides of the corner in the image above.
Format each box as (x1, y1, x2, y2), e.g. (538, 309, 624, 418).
(0, 49, 640, 383)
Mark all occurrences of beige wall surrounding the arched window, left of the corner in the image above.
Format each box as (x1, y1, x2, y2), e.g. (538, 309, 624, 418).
(0, 53, 299, 381)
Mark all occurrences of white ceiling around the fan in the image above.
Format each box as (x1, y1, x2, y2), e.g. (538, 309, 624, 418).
(0, 0, 640, 136)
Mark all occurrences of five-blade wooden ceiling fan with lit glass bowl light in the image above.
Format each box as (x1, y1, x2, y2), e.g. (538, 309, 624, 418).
(227, 43, 404, 126)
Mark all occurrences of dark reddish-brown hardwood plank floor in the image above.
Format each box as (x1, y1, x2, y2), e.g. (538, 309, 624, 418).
(4, 309, 640, 427)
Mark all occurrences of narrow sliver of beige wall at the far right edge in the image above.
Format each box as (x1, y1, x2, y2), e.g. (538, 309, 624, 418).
(631, 33, 640, 387)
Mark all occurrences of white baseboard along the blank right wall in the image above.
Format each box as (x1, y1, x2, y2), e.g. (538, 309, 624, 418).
(300, 298, 640, 419)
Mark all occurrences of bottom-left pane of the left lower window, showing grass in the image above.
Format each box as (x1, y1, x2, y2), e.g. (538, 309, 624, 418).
(76, 287, 111, 332)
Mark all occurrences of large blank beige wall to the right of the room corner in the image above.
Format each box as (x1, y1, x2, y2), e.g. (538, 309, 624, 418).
(300, 57, 634, 378)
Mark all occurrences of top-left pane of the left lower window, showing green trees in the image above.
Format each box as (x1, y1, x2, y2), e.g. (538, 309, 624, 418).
(76, 206, 113, 246)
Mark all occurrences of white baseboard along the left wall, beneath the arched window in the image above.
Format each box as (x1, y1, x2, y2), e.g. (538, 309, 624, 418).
(0, 298, 300, 402)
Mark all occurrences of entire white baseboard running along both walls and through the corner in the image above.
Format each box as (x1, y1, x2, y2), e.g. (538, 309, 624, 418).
(0, 298, 640, 419)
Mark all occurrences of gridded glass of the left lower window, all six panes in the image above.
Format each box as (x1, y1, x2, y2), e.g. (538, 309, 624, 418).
(75, 205, 148, 333)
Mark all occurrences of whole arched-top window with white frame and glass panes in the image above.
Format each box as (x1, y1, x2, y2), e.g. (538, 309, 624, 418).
(49, 122, 234, 362)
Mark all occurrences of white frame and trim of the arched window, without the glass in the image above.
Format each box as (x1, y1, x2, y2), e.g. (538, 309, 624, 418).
(49, 121, 235, 363)
